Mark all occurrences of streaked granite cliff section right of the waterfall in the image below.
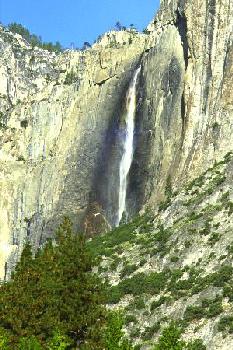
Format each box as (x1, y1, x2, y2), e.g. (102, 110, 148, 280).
(128, 0, 233, 212)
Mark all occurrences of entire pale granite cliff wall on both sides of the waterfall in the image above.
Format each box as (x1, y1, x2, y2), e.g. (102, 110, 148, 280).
(0, 0, 233, 279)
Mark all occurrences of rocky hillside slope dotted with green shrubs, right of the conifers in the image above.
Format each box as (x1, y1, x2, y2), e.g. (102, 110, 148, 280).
(88, 152, 233, 350)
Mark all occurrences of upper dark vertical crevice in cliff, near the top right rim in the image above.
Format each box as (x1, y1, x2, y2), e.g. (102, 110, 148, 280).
(175, 7, 189, 69)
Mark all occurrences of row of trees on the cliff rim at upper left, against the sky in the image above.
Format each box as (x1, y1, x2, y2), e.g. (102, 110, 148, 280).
(8, 22, 62, 53)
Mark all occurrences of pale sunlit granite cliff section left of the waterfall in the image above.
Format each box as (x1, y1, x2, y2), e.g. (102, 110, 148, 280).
(0, 28, 145, 278)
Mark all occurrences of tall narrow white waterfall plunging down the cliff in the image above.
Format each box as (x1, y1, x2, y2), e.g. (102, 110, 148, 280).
(117, 67, 141, 226)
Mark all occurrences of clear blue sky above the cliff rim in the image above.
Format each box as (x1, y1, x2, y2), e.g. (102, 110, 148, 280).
(0, 0, 159, 47)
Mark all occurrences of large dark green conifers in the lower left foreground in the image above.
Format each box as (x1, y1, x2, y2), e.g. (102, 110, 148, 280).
(0, 218, 107, 350)
